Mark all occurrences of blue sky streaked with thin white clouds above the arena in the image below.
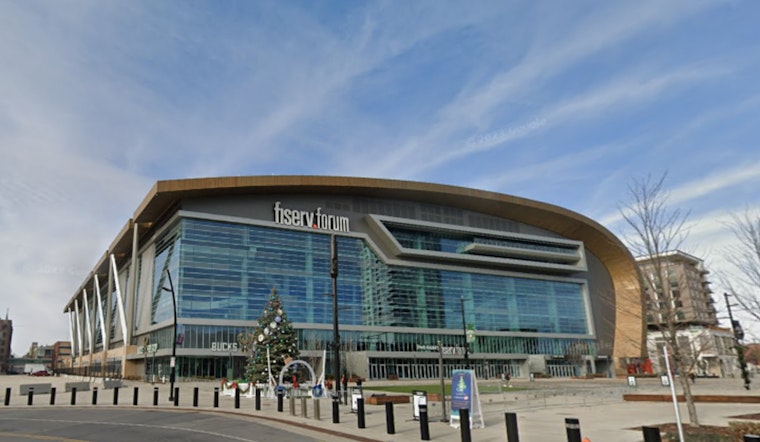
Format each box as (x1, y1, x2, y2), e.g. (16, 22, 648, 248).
(0, 0, 760, 354)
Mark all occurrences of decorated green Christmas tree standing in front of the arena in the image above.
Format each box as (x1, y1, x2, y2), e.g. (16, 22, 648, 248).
(238, 288, 298, 383)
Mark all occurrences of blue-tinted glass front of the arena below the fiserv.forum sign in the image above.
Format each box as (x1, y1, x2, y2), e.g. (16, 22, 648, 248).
(151, 218, 591, 360)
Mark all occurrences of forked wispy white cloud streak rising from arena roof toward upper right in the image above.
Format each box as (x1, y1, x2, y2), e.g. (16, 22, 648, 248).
(348, 2, 722, 177)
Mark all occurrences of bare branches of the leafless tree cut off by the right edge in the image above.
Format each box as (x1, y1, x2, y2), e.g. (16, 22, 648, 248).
(722, 208, 760, 321)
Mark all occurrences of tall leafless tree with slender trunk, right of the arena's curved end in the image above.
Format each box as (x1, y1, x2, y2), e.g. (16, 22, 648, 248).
(620, 174, 699, 426)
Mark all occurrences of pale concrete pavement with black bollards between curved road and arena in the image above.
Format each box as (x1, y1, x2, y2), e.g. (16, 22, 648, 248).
(0, 375, 760, 442)
